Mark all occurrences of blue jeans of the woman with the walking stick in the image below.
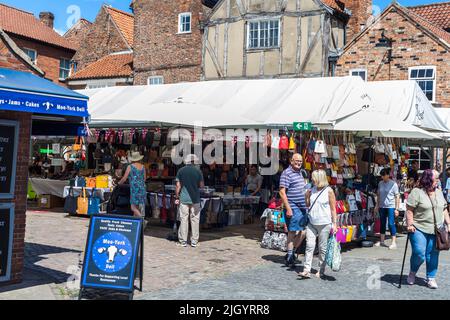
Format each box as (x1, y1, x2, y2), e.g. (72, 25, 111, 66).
(409, 229, 439, 279)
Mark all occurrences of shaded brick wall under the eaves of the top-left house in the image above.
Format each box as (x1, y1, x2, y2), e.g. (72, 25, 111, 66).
(10, 35, 75, 86)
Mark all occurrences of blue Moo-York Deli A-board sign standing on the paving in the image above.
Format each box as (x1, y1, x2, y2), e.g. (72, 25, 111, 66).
(81, 215, 142, 292)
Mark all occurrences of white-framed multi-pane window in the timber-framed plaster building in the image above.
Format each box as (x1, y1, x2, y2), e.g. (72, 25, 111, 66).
(247, 19, 280, 49)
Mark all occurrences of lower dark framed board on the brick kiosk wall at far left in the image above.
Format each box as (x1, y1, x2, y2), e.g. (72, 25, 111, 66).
(0, 203, 14, 282)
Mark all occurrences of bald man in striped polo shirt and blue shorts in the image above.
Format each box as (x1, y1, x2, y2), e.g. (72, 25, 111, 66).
(280, 153, 308, 266)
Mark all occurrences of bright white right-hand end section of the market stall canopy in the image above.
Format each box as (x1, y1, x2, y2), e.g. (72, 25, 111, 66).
(367, 80, 450, 132)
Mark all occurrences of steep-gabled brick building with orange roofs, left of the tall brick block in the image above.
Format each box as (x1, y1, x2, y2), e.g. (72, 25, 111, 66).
(66, 5, 134, 89)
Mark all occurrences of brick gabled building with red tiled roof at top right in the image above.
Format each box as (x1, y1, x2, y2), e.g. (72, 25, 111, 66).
(336, 2, 450, 107)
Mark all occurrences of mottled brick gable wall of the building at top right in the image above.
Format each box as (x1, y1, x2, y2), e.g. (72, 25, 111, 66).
(336, 10, 450, 107)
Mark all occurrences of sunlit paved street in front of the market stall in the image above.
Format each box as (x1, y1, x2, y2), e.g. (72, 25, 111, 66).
(0, 211, 450, 299)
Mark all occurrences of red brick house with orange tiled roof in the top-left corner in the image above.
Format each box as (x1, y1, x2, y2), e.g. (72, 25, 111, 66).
(0, 4, 76, 85)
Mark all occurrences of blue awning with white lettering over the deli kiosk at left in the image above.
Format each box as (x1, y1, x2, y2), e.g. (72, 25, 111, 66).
(0, 68, 89, 117)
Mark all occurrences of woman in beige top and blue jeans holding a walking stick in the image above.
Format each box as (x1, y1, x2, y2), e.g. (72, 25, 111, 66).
(406, 170, 450, 289)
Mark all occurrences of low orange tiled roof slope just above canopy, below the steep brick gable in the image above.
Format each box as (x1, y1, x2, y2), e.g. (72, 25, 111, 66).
(69, 53, 133, 80)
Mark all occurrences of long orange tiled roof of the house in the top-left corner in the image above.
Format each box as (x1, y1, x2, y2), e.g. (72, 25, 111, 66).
(0, 3, 75, 50)
